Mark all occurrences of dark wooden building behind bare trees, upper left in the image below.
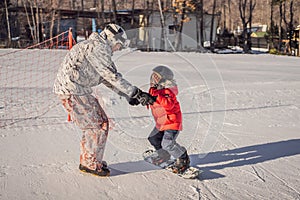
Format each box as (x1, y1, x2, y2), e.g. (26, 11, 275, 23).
(0, 3, 143, 48)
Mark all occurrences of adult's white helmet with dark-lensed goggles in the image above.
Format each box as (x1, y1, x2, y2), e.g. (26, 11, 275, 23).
(102, 24, 129, 48)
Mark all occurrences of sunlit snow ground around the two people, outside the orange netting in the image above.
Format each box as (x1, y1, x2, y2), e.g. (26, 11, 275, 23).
(0, 50, 300, 200)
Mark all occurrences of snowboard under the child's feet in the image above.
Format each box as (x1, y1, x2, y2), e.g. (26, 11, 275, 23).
(143, 150, 202, 179)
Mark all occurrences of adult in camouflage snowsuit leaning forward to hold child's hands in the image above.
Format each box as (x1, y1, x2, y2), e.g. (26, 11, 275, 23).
(54, 24, 155, 176)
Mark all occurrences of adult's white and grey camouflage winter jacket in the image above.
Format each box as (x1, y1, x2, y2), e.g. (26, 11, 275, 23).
(54, 33, 135, 97)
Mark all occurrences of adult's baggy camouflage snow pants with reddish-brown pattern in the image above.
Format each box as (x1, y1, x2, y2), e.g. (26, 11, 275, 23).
(60, 94, 109, 170)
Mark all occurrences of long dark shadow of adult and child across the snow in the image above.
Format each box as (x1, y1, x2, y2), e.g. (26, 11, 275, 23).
(109, 139, 300, 180)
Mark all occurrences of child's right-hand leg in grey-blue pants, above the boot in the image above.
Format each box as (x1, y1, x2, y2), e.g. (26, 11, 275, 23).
(161, 130, 186, 158)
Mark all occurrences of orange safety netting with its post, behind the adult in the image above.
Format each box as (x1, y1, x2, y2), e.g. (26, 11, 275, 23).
(0, 30, 75, 128)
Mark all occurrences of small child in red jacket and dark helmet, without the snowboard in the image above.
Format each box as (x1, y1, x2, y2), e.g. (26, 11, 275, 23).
(148, 66, 190, 173)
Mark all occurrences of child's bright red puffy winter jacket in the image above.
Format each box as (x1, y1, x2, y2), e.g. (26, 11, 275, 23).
(149, 86, 182, 131)
